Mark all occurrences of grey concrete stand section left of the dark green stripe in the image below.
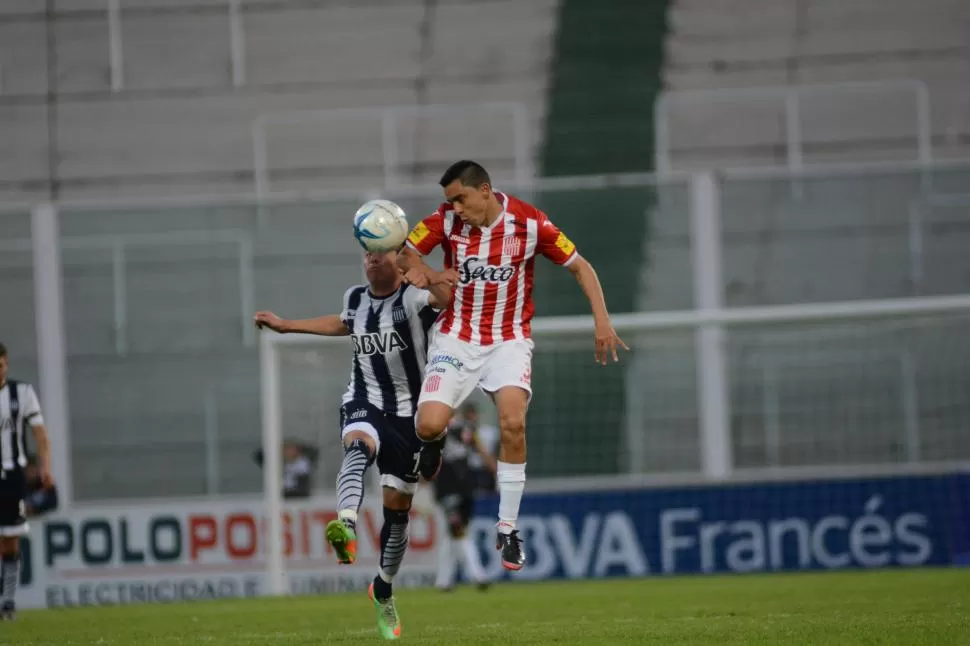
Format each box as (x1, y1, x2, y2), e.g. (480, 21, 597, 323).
(0, 0, 556, 200)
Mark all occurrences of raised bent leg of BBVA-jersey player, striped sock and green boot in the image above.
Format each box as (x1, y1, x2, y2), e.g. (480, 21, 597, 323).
(326, 402, 381, 564)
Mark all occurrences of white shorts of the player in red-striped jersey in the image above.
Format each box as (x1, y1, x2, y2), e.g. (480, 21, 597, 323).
(418, 332, 534, 408)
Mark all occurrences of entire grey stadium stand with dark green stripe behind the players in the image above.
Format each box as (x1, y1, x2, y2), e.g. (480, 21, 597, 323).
(0, 0, 970, 499)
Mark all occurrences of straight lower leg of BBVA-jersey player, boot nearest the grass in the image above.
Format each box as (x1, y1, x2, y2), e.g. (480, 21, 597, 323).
(368, 415, 422, 639)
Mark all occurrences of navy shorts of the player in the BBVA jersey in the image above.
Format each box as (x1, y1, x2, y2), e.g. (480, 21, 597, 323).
(340, 399, 423, 496)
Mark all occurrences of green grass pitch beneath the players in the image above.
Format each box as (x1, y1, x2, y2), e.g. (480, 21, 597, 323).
(7, 569, 970, 646)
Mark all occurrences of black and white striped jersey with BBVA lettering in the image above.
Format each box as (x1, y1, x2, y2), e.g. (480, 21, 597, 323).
(340, 284, 438, 417)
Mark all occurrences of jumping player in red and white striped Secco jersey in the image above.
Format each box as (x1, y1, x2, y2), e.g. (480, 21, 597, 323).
(398, 161, 626, 570)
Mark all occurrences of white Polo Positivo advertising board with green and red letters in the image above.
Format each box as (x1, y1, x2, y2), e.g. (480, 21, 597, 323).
(21, 499, 441, 607)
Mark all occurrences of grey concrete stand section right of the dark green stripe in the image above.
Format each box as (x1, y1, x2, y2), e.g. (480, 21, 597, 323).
(664, 0, 970, 169)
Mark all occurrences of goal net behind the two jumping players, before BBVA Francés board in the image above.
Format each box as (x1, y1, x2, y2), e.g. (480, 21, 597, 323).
(262, 296, 970, 596)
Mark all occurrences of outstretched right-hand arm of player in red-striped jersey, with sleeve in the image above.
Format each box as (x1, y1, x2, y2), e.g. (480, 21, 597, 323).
(536, 214, 629, 365)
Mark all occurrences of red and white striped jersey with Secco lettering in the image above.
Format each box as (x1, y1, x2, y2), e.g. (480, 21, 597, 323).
(408, 193, 578, 345)
